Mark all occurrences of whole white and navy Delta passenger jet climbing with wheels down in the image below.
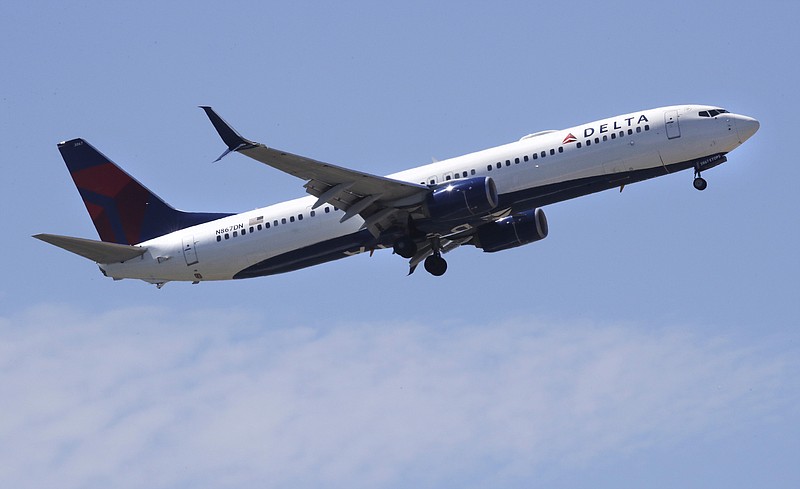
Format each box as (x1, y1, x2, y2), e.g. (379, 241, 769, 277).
(33, 105, 759, 289)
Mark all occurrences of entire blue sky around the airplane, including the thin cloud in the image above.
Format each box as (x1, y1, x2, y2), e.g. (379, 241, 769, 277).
(0, 2, 800, 488)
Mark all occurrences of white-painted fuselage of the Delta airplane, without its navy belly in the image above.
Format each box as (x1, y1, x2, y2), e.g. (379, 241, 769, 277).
(101, 105, 757, 283)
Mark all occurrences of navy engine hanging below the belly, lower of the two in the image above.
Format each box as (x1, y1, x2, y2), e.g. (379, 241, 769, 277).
(474, 209, 547, 253)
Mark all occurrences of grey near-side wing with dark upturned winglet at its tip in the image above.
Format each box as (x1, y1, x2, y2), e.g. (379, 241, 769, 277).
(201, 106, 430, 237)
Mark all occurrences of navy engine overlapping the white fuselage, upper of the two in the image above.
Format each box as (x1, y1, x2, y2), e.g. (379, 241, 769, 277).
(425, 177, 498, 221)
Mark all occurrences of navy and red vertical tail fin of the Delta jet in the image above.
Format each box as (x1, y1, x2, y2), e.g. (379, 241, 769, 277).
(58, 139, 231, 245)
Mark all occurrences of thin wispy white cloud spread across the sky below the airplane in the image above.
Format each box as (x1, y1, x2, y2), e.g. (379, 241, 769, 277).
(0, 307, 795, 488)
